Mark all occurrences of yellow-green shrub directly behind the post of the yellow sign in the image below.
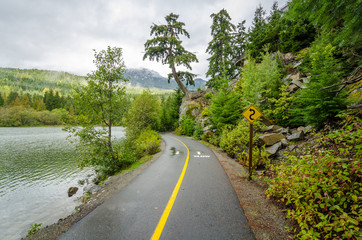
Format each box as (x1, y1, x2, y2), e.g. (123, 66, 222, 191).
(219, 121, 270, 169)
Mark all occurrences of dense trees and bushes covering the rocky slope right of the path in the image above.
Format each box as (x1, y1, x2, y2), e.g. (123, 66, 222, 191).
(170, 0, 362, 239)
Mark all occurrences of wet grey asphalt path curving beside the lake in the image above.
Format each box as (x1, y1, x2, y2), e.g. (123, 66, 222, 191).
(58, 134, 255, 240)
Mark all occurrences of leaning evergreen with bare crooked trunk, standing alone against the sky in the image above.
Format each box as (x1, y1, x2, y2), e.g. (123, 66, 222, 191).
(143, 13, 198, 94)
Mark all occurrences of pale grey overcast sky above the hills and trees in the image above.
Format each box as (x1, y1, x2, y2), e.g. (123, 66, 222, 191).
(0, 0, 287, 78)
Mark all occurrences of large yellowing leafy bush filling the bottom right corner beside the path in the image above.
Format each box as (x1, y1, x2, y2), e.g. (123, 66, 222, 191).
(266, 113, 362, 239)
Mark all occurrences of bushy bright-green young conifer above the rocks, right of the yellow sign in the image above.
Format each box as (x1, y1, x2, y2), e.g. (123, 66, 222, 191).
(291, 43, 346, 127)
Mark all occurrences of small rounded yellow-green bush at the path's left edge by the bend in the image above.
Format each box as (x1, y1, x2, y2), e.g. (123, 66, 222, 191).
(135, 129, 161, 155)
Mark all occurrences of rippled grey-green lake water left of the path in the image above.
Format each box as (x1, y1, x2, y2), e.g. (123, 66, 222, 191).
(0, 127, 124, 240)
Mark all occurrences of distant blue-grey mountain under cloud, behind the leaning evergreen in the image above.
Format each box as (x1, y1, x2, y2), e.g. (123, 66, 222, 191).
(125, 68, 206, 90)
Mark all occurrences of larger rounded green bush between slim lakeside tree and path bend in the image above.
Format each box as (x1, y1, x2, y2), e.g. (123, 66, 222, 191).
(126, 91, 161, 139)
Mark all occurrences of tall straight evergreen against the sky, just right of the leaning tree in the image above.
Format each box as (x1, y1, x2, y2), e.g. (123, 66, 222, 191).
(206, 9, 236, 89)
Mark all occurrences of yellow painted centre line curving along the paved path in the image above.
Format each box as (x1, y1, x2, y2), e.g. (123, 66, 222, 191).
(151, 137, 190, 240)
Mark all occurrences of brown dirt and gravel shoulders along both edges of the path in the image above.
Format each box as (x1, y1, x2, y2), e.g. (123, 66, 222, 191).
(26, 139, 292, 240)
